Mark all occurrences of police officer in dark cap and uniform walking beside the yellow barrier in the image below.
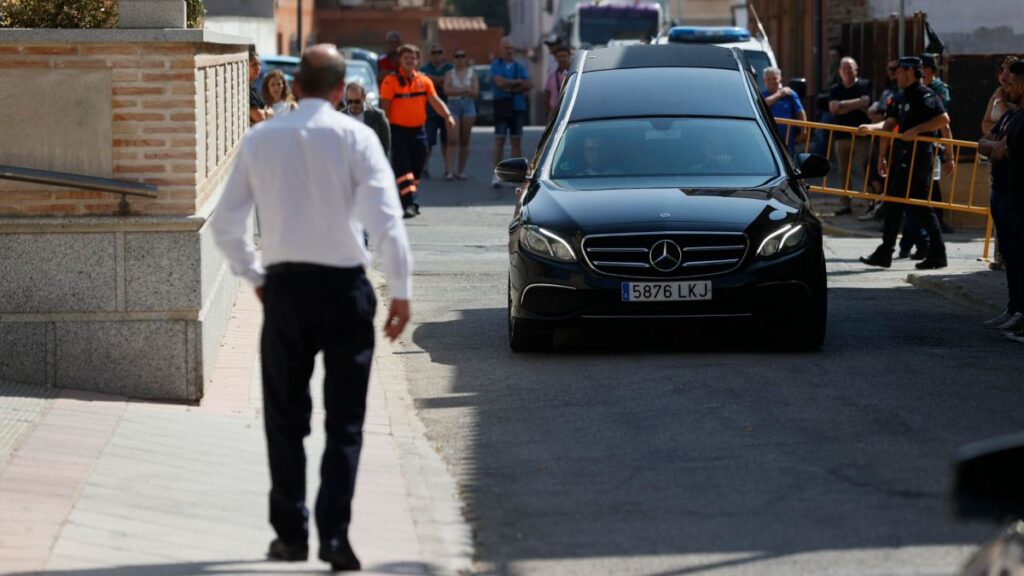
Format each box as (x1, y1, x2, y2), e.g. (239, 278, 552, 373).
(858, 57, 949, 270)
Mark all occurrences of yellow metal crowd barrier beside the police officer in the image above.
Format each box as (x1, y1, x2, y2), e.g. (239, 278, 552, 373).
(775, 118, 992, 258)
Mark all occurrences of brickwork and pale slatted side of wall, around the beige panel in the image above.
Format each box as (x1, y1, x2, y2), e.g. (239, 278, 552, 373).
(0, 43, 248, 215)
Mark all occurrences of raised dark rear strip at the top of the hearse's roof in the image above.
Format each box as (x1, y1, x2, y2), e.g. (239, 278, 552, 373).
(578, 44, 739, 73)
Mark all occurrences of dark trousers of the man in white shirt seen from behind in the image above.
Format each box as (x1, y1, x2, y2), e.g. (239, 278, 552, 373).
(260, 264, 377, 543)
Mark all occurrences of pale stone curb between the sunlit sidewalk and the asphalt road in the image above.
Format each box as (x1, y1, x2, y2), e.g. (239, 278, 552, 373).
(368, 269, 474, 576)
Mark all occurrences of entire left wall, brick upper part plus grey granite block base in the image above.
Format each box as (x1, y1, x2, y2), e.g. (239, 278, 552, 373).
(0, 30, 248, 401)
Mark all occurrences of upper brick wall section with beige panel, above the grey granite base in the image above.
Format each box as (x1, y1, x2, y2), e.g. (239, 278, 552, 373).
(0, 31, 248, 215)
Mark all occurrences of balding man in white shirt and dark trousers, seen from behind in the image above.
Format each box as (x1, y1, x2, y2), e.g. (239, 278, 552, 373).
(211, 44, 412, 570)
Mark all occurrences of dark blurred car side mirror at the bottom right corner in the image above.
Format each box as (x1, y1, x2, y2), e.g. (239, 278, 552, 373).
(950, 434, 1024, 522)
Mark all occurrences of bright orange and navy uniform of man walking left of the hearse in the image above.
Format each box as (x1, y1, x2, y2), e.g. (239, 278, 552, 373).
(380, 70, 437, 218)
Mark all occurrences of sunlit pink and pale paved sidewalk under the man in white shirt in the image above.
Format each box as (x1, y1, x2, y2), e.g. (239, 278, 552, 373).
(0, 280, 472, 576)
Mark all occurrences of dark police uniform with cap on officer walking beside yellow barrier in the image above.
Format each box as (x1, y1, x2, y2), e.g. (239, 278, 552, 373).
(861, 57, 946, 269)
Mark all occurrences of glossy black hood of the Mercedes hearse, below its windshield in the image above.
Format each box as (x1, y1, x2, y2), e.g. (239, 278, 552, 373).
(528, 180, 801, 234)
